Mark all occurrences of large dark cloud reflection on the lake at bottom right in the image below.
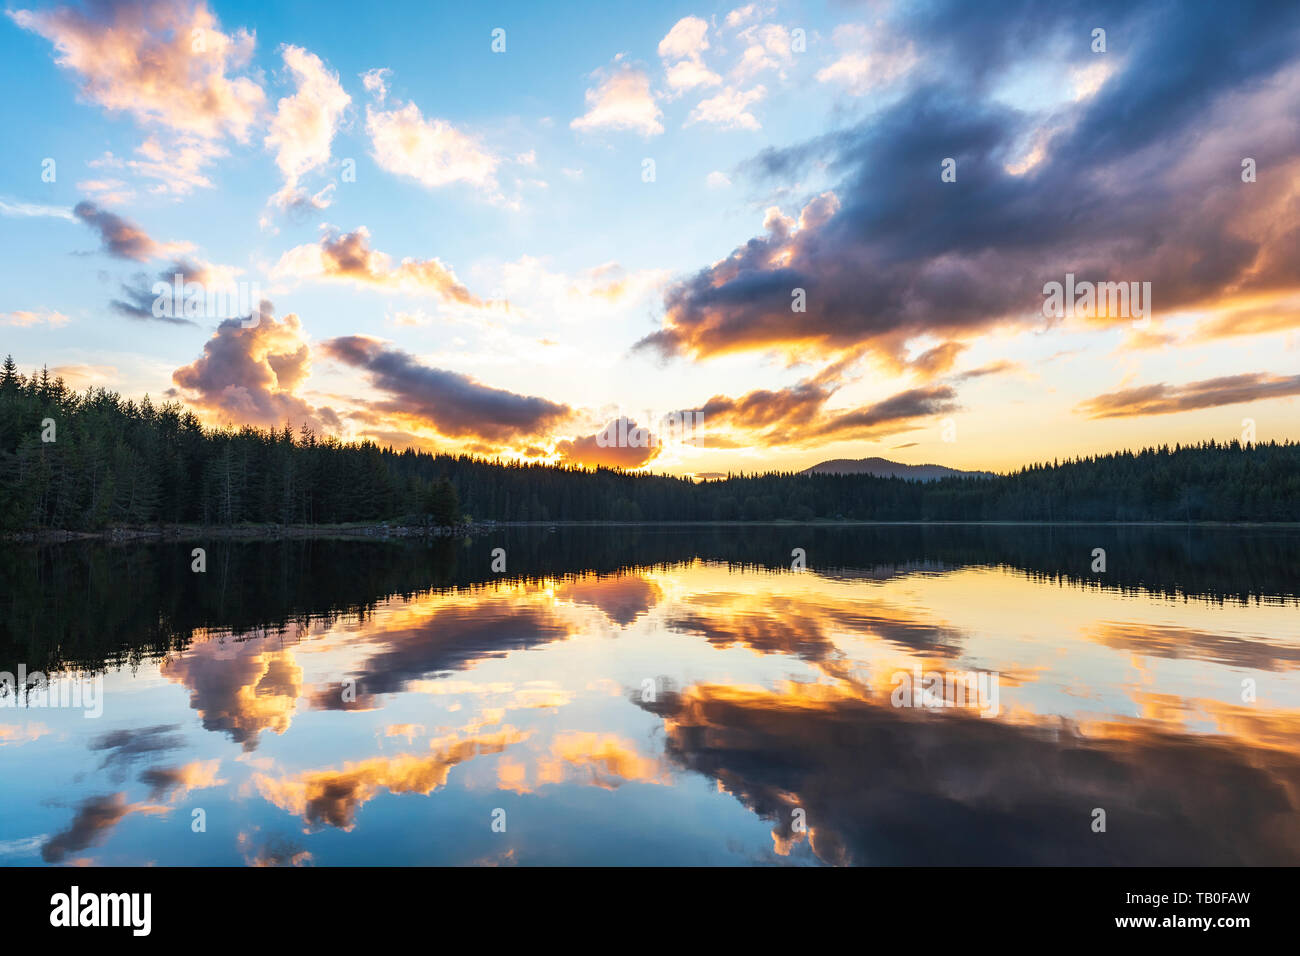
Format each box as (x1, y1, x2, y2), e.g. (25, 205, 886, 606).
(642, 685, 1300, 866)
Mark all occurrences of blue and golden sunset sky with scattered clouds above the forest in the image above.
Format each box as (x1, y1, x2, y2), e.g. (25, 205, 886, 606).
(0, 0, 1300, 476)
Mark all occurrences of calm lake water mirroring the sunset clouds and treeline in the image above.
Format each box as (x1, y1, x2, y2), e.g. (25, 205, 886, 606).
(0, 525, 1300, 866)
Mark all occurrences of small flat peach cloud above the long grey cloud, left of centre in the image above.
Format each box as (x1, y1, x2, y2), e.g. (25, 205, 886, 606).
(270, 226, 484, 307)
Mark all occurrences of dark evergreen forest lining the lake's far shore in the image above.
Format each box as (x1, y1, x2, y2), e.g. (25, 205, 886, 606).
(0, 358, 1300, 532)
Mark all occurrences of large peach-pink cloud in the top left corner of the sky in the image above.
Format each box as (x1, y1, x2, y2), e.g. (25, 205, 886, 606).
(8, 0, 265, 194)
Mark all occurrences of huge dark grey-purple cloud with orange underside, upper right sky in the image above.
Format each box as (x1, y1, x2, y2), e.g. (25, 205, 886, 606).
(641, 3, 1300, 364)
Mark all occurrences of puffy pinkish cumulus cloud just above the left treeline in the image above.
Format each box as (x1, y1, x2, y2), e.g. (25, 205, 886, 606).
(172, 302, 341, 432)
